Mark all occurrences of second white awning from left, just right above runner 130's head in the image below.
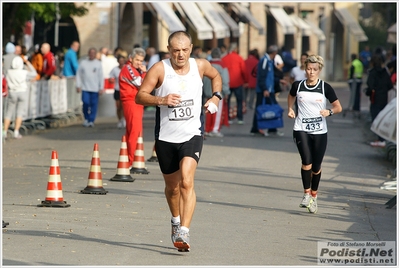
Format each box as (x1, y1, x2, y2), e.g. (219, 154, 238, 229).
(174, 2, 213, 40)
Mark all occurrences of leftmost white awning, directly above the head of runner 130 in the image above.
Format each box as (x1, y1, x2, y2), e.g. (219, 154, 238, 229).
(145, 2, 186, 33)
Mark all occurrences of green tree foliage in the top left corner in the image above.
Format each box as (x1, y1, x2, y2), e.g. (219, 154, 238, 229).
(2, 2, 88, 45)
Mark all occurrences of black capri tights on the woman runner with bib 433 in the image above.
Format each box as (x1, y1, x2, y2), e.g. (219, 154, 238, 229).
(293, 130, 327, 173)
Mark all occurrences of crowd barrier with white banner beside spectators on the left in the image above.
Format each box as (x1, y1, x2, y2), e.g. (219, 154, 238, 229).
(3, 78, 82, 132)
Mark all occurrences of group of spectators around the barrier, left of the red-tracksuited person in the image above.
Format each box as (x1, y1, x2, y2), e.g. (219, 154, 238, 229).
(2, 40, 134, 139)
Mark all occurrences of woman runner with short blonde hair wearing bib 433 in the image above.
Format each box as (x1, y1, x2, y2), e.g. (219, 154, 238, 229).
(287, 55, 342, 213)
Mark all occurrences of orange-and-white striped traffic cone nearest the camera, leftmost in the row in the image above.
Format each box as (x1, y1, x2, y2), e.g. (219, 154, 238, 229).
(37, 151, 71, 208)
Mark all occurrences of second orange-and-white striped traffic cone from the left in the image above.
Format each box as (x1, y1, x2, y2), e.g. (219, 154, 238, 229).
(80, 143, 108, 194)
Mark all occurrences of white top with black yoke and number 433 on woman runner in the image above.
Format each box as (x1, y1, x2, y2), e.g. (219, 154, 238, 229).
(294, 79, 327, 134)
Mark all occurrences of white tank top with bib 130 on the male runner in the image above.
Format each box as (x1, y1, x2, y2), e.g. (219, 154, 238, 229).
(155, 58, 202, 143)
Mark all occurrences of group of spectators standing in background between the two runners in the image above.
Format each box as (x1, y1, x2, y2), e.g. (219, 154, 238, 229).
(197, 43, 300, 137)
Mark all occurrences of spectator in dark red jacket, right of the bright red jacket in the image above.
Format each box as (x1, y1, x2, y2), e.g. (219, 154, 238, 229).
(244, 48, 259, 109)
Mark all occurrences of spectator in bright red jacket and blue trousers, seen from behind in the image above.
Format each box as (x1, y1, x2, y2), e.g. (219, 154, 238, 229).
(222, 43, 248, 125)
